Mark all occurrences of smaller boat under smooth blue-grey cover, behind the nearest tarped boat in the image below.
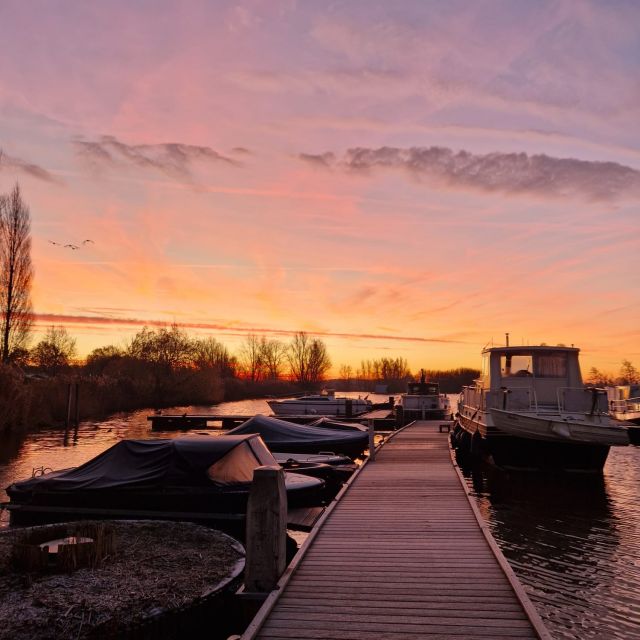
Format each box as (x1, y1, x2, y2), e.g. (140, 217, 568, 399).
(227, 414, 369, 457)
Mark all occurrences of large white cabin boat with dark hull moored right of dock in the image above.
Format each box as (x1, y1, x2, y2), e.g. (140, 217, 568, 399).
(452, 345, 629, 471)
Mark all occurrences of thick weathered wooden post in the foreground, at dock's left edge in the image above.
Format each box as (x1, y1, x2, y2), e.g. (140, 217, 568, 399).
(244, 466, 287, 592)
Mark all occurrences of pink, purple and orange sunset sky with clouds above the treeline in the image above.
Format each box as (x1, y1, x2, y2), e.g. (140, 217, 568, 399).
(0, 0, 640, 372)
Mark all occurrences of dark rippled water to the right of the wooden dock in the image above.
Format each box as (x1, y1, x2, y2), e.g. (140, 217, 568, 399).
(464, 448, 640, 639)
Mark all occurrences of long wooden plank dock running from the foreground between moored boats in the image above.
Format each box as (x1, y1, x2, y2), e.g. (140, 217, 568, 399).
(242, 421, 550, 640)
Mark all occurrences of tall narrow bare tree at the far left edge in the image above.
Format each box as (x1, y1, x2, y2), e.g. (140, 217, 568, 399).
(0, 183, 33, 362)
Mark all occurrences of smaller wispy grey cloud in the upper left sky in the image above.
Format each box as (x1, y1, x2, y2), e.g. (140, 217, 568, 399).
(73, 136, 239, 179)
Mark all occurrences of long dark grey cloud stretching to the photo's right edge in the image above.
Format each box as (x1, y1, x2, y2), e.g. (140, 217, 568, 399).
(299, 147, 640, 200)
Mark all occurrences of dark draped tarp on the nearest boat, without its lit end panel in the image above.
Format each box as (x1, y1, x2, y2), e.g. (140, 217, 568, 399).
(8, 435, 258, 491)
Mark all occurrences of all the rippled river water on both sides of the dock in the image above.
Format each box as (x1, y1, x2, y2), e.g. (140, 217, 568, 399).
(0, 393, 640, 640)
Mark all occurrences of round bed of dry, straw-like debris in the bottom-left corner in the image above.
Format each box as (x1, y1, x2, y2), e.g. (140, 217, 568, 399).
(0, 521, 243, 640)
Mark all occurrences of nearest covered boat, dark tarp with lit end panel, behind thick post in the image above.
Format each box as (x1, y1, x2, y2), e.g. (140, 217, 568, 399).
(7, 433, 323, 524)
